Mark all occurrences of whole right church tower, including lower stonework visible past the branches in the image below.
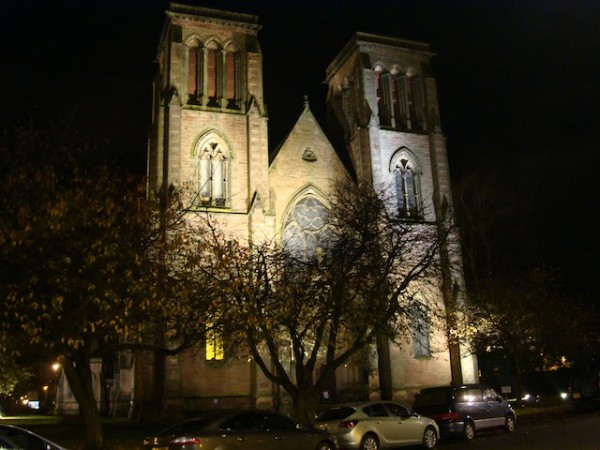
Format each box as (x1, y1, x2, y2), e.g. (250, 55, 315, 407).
(327, 33, 477, 397)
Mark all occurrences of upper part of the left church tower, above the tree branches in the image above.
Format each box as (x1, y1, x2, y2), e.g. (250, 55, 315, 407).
(148, 3, 269, 238)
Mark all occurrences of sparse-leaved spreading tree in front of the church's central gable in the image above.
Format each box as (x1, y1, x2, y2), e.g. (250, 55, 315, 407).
(190, 182, 450, 423)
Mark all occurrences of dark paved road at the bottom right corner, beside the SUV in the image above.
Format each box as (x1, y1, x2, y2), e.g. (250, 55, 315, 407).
(439, 412, 600, 450)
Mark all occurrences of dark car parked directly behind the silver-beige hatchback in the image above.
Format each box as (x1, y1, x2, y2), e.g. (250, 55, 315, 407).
(144, 410, 337, 450)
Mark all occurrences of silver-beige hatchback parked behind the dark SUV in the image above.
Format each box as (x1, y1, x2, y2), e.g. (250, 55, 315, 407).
(315, 401, 440, 450)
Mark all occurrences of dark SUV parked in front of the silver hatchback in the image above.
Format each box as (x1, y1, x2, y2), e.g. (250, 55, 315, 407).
(413, 384, 517, 440)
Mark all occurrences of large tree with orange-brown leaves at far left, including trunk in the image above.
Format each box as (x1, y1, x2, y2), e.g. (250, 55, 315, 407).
(0, 131, 173, 449)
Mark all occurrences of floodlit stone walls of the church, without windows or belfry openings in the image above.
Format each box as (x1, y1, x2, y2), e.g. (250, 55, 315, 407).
(135, 5, 477, 418)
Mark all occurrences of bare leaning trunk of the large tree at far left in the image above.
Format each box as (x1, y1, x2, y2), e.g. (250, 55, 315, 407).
(61, 351, 104, 450)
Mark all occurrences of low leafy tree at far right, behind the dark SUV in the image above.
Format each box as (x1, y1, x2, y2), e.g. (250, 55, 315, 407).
(470, 268, 600, 392)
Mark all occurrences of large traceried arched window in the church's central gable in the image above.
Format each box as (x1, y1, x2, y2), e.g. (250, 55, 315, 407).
(283, 195, 331, 258)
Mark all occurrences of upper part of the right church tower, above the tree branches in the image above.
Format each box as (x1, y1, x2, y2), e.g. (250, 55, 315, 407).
(327, 33, 442, 214)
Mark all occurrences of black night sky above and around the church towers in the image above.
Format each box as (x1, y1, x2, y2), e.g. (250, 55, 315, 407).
(0, 0, 600, 292)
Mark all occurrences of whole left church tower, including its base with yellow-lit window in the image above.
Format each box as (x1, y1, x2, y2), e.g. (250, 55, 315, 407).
(142, 3, 275, 413)
